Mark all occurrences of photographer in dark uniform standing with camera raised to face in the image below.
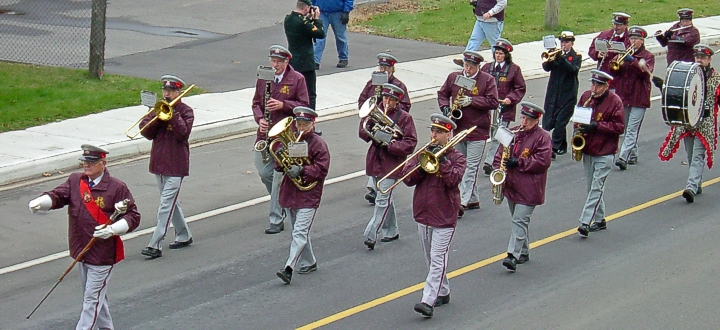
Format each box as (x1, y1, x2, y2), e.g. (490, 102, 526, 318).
(283, 0, 325, 109)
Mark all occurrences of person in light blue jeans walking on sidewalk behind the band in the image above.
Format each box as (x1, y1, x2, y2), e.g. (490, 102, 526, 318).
(453, 0, 507, 66)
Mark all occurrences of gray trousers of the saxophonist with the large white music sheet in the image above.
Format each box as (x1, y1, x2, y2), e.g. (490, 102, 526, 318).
(579, 154, 614, 225)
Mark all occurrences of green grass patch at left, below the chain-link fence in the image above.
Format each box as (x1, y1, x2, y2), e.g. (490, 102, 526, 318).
(0, 62, 203, 132)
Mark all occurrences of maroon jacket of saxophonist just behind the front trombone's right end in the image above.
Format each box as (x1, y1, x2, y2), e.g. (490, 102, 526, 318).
(438, 71, 499, 141)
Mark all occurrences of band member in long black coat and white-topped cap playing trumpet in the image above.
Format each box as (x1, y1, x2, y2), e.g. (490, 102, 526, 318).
(542, 31, 582, 159)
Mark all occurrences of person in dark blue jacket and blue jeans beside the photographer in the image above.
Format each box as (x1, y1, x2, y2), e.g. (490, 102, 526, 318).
(312, 0, 354, 70)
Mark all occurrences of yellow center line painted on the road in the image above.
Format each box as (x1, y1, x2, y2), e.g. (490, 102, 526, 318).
(297, 177, 720, 330)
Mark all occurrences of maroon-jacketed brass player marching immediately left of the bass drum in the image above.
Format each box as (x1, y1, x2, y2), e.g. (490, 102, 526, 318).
(615, 26, 655, 171)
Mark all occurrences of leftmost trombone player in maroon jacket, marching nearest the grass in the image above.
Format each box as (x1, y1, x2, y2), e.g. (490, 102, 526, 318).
(140, 75, 195, 259)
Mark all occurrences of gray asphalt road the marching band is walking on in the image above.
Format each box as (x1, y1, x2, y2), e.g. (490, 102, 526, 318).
(0, 58, 720, 329)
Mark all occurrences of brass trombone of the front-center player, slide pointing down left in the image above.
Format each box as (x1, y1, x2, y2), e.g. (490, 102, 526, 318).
(375, 126, 477, 194)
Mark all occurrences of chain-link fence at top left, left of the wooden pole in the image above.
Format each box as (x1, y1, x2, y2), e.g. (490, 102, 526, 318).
(0, 0, 93, 68)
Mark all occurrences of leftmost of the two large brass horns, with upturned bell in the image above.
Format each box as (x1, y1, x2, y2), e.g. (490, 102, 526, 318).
(267, 117, 317, 191)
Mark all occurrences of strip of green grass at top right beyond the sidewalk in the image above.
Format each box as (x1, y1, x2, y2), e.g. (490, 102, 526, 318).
(357, 0, 720, 46)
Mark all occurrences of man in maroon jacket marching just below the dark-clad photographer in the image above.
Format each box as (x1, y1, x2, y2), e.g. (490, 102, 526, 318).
(252, 45, 310, 234)
